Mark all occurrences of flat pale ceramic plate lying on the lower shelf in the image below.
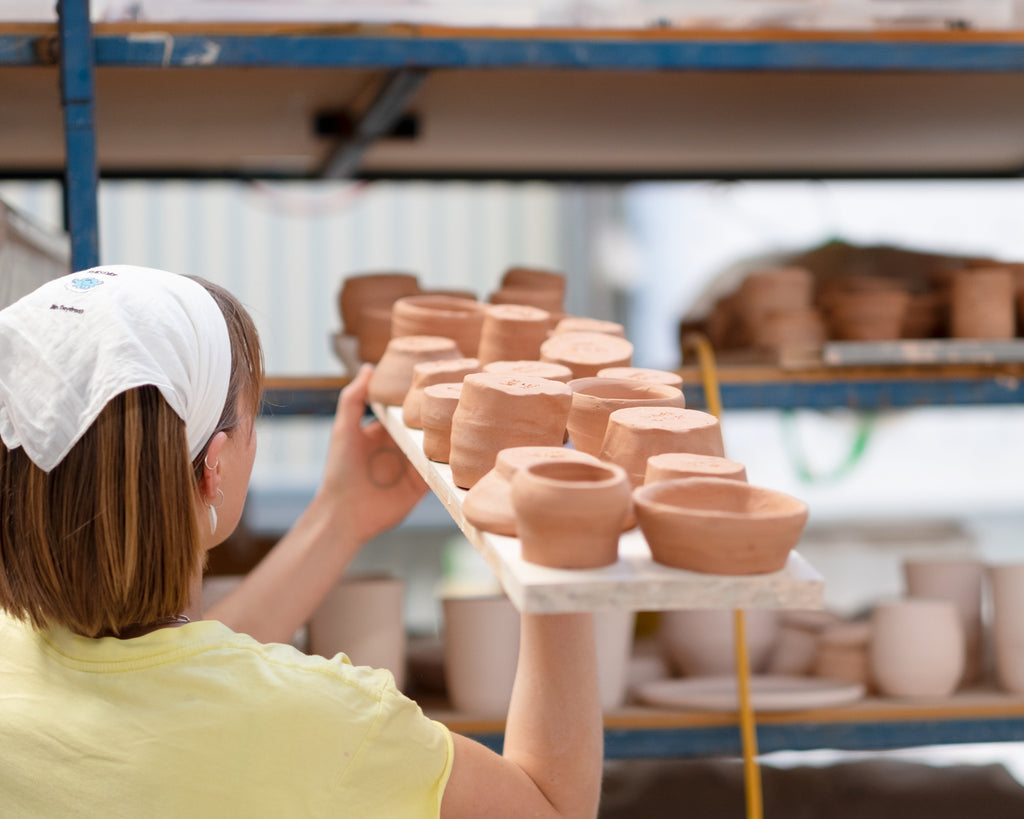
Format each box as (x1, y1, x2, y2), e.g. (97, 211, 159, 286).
(635, 675, 864, 712)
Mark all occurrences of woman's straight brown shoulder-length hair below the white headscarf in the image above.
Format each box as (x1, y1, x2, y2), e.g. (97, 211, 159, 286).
(0, 281, 263, 637)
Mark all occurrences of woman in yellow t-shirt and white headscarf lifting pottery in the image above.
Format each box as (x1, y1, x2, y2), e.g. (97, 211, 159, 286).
(0, 266, 602, 819)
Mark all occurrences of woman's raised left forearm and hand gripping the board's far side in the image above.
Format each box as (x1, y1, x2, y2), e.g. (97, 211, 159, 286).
(204, 365, 426, 642)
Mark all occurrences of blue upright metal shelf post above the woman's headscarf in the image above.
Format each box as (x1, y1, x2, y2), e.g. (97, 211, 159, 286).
(57, 0, 99, 270)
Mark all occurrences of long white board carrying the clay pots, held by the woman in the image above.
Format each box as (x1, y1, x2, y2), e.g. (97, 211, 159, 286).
(371, 403, 824, 613)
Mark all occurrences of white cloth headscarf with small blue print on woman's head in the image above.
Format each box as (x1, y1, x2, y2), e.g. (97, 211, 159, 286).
(0, 265, 231, 472)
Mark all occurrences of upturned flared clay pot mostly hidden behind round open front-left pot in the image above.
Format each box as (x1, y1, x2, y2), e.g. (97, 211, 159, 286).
(462, 446, 601, 537)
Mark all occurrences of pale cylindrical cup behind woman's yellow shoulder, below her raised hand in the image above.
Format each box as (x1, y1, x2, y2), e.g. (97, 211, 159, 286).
(309, 574, 406, 688)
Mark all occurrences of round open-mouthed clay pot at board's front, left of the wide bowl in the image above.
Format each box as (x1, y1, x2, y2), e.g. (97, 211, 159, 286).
(511, 461, 631, 569)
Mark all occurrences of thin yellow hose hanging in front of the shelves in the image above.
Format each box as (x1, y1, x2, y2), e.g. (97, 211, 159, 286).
(681, 333, 764, 819)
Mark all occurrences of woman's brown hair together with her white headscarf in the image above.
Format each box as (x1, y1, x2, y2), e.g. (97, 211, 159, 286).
(0, 266, 263, 636)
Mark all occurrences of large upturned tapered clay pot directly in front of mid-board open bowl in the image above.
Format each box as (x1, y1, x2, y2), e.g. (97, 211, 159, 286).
(598, 406, 725, 487)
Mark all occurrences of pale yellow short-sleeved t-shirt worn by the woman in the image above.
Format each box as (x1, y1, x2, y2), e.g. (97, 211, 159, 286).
(0, 612, 453, 819)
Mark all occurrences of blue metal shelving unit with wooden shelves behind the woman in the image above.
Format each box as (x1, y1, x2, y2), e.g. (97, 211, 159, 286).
(8, 0, 1024, 758)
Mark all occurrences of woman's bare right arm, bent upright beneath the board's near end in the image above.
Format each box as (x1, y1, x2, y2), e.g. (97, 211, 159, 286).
(441, 614, 604, 819)
